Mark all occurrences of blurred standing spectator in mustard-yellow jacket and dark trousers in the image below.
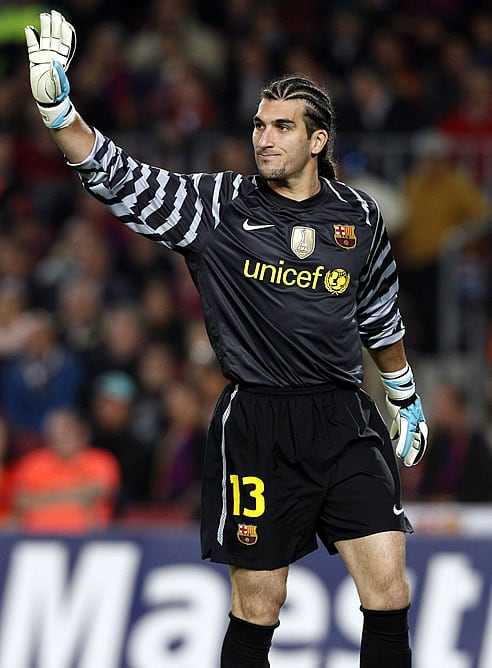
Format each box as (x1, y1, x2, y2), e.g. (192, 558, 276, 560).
(397, 130, 488, 353)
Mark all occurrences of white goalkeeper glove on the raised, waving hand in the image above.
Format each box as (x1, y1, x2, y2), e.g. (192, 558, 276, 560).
(25, 10, 76, 129)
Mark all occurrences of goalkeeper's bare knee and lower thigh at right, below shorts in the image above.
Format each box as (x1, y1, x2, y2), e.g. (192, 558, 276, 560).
(336, 531, 410, 610)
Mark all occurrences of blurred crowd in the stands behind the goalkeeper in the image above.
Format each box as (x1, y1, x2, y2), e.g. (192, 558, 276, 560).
(0, 0, 492, 530)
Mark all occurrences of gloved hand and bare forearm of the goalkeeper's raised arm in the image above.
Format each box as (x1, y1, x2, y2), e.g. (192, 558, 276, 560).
(25, 10, 95, 163)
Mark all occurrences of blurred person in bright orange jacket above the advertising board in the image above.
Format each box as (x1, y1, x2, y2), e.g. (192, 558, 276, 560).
(10, 409, 120, 533)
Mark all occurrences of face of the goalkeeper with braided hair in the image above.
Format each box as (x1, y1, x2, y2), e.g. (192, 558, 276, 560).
(253, 100, 316, 182)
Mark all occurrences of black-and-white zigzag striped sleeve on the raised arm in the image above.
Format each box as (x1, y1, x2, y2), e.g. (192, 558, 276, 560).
(70, 130, 241, 252)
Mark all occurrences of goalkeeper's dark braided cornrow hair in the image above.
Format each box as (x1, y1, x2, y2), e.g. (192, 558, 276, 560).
(260, 75, 336, 179)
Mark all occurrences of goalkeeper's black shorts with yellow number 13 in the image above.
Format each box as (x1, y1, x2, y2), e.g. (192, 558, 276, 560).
(201, 385, 412, 570)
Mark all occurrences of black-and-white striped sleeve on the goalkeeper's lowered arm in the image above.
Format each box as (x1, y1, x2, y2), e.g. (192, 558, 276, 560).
(357, 198, 405, 348)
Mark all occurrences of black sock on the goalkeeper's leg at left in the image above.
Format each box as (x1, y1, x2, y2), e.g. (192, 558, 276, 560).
(220, 613, 278, 668)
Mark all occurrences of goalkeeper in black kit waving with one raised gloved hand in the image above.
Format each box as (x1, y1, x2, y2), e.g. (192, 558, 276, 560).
(26, 11, 427, 668)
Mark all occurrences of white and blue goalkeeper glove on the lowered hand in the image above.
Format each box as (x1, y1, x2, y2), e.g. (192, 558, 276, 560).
(381, 364, 428, 466)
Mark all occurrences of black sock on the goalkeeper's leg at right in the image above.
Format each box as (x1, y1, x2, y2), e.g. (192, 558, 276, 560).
(360, 606, 412, 668)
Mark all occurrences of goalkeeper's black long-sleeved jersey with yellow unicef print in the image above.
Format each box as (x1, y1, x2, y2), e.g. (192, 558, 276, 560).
(72, 132, 404, 387)
